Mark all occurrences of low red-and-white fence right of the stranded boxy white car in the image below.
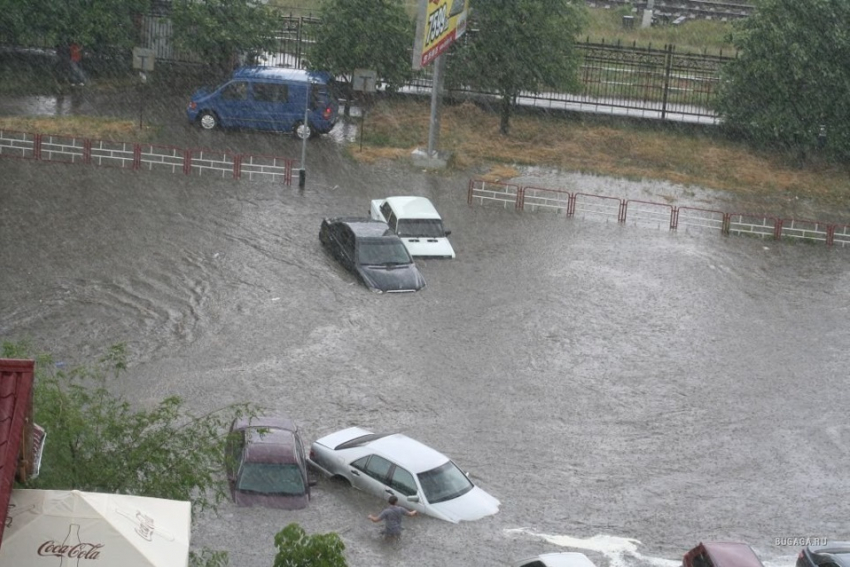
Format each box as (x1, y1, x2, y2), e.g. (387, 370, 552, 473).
(467, 179, 850, 247)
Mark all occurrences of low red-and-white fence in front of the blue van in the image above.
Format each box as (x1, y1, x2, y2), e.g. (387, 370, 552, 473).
(0, 130, 298, 185)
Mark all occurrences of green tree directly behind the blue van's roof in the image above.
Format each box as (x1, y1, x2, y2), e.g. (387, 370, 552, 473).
(171, 0, 279, 74)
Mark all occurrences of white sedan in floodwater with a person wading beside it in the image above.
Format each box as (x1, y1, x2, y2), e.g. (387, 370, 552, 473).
(308, 427, 500, 523)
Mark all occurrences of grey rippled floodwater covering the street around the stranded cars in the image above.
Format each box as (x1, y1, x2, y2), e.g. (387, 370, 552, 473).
(0, 95, 850, 567)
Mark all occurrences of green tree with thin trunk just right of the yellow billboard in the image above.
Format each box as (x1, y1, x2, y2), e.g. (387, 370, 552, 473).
(446, 0, 586, 134)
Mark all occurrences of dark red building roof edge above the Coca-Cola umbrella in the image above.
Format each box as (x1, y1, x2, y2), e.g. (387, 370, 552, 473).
(0, 359, 35, 545)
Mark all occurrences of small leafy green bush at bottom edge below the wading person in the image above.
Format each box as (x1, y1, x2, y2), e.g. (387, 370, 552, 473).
(274, 523, 348, 567)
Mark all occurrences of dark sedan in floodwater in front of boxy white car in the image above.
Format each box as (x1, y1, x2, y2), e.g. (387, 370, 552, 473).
(319, 217, 425, 293)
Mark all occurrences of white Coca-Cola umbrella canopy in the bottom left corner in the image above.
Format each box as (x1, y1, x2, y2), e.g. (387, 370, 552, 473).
(0, 490, 192, 567)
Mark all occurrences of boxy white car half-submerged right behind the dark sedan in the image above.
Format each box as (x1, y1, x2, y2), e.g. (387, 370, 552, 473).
(369, 197, 455, 258)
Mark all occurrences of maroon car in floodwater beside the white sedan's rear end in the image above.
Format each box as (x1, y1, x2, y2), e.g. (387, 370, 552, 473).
(225, 416, 311, 510)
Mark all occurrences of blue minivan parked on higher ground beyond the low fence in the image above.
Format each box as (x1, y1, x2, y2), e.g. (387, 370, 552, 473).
(186, 67, 339, 139)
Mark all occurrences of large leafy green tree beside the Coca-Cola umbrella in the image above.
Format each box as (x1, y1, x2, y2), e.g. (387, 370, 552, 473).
(2, 343, 253, 567)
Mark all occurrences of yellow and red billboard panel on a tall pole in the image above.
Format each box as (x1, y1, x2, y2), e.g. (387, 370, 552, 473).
(413, 0, 469, 70)
